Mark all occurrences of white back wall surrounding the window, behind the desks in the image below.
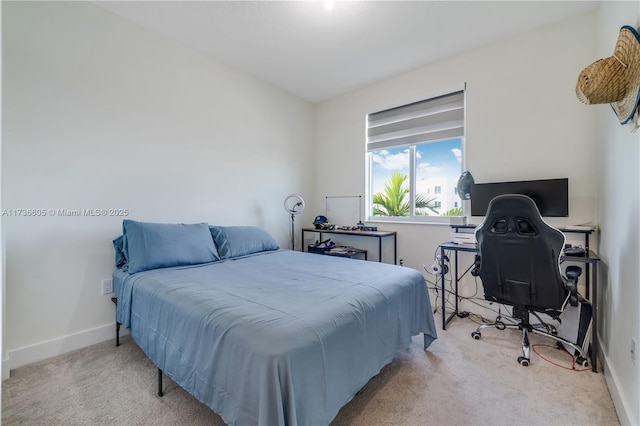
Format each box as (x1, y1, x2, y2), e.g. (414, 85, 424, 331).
(314, 13, 598, 280)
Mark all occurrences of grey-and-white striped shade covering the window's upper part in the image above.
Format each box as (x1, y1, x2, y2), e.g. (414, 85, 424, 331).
(367, 91, 464, 151)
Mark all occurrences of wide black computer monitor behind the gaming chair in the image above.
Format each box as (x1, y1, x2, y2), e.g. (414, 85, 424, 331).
(471, 178, 569, 217)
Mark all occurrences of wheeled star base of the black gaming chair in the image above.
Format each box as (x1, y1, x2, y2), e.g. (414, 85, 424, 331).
(471, 316, 588, 367)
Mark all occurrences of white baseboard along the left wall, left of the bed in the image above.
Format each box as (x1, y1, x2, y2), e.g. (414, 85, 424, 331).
(2, 323, 128, 380)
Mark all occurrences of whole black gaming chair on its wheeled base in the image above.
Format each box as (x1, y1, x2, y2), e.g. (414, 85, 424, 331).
(471, 194, 587, 366)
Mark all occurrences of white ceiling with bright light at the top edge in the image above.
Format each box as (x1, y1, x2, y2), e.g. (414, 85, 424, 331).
(94, 0, 599, 102)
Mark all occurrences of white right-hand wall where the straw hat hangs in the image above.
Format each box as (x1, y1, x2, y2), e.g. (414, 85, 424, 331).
(589, 2, 640, 425)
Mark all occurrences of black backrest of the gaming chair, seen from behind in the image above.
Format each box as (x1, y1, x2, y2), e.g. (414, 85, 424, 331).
(475, 194, 568, 312)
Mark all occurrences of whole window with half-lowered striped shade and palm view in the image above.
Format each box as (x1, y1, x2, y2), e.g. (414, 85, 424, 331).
(367, 90, 464, 222)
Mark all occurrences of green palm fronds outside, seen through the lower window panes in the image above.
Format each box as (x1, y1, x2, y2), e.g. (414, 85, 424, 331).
(373, 172, 438, 216)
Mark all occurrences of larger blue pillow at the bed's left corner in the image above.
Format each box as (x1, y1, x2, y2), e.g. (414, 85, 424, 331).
(122, 219, 220, 274)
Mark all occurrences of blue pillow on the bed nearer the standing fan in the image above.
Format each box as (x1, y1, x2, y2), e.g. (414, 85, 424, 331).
(209, 226, 280, 259)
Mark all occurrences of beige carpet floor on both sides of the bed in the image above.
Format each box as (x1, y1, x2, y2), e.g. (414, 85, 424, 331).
(2, 318, 619, 425)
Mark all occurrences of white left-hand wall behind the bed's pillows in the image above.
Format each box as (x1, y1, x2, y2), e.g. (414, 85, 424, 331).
(2, 2, 314, 368)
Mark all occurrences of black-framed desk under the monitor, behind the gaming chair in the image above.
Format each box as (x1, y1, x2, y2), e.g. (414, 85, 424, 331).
(440, 242, 600, 373)
